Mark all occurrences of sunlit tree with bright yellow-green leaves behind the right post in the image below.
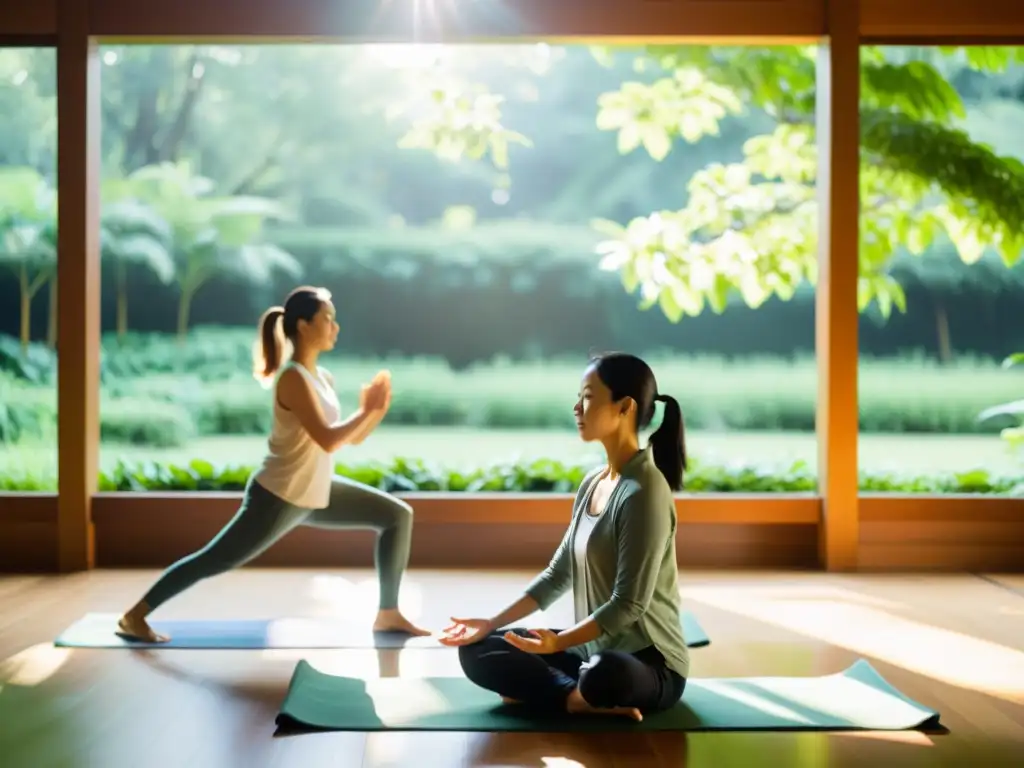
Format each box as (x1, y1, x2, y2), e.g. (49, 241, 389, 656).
(401, 46, 1024, 321)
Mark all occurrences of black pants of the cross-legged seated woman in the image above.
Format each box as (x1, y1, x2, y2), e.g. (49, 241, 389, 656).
(459, 629, 686, 713)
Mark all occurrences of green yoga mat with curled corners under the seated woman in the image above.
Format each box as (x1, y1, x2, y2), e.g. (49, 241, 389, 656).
(276, 659, 939, 732)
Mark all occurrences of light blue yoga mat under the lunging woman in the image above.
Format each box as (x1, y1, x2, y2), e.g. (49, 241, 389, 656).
(54, 611, 711, 650)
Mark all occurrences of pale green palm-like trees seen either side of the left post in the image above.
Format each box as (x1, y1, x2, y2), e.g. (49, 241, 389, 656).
(0, 163, 302, 348)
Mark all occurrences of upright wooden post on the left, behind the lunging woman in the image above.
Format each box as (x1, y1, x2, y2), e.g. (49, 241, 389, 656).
(57, 0, 100, 571)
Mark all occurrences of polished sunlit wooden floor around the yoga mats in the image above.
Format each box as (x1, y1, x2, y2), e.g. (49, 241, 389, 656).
(0, 569, 1024, 768)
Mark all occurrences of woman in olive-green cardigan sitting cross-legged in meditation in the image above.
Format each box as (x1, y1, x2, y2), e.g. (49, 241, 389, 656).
(441, 354, 689, 720)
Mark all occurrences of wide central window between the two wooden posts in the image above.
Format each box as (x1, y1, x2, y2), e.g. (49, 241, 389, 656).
(90, 45, 817, 490)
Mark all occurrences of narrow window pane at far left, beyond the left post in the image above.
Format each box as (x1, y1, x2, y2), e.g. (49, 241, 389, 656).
(0, 47, 57, 493)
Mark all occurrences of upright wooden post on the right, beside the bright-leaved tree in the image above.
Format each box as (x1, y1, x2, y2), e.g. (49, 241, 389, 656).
(815, 0, 860, 570)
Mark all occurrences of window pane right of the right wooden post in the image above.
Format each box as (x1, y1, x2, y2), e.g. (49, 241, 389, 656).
(859, 47, 1024, 493)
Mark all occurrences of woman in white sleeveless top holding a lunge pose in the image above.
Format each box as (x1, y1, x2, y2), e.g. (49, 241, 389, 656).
(118, 287, 430, 642)
